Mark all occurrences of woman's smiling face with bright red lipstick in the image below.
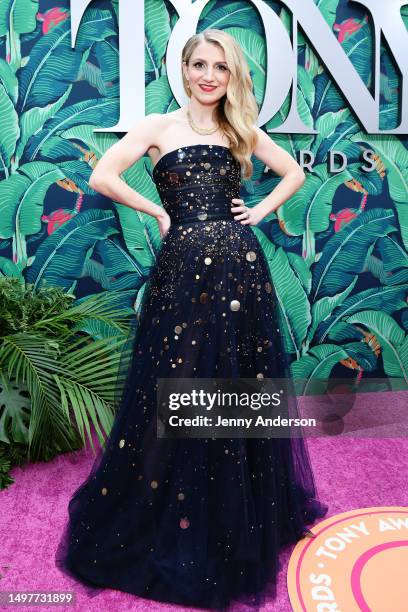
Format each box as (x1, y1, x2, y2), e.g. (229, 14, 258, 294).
(183, 42, 230, 104)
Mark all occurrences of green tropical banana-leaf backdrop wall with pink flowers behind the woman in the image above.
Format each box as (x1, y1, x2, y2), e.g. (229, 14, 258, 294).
(0, 0, 408, 390)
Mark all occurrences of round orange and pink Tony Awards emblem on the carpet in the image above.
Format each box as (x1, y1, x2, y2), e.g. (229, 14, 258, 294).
(287, 506, 408, 612)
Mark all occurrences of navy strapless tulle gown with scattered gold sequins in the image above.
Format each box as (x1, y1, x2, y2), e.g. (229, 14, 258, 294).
(56, 144, 328, 610)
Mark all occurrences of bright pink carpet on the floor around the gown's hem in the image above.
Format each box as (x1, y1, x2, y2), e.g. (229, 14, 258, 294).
(0, 437, 408, 612)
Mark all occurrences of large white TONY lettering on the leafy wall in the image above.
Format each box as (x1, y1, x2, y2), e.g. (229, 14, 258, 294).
(70, 0, 408, 134)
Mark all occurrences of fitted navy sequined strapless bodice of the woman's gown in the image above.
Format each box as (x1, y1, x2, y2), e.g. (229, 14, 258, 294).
(153, 144, 241, 223)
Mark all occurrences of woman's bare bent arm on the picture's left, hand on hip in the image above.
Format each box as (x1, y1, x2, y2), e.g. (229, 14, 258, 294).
(88, 113, 168, 224)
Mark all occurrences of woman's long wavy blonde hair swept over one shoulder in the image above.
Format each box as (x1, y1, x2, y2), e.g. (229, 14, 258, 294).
(181, 28, 259, 179)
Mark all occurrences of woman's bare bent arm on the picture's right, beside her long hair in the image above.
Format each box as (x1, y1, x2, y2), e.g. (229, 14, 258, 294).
(252, 126, 306, 222)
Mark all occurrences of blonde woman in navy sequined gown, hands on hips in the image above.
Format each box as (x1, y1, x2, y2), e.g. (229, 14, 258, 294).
(57, 29, 327, 609)
